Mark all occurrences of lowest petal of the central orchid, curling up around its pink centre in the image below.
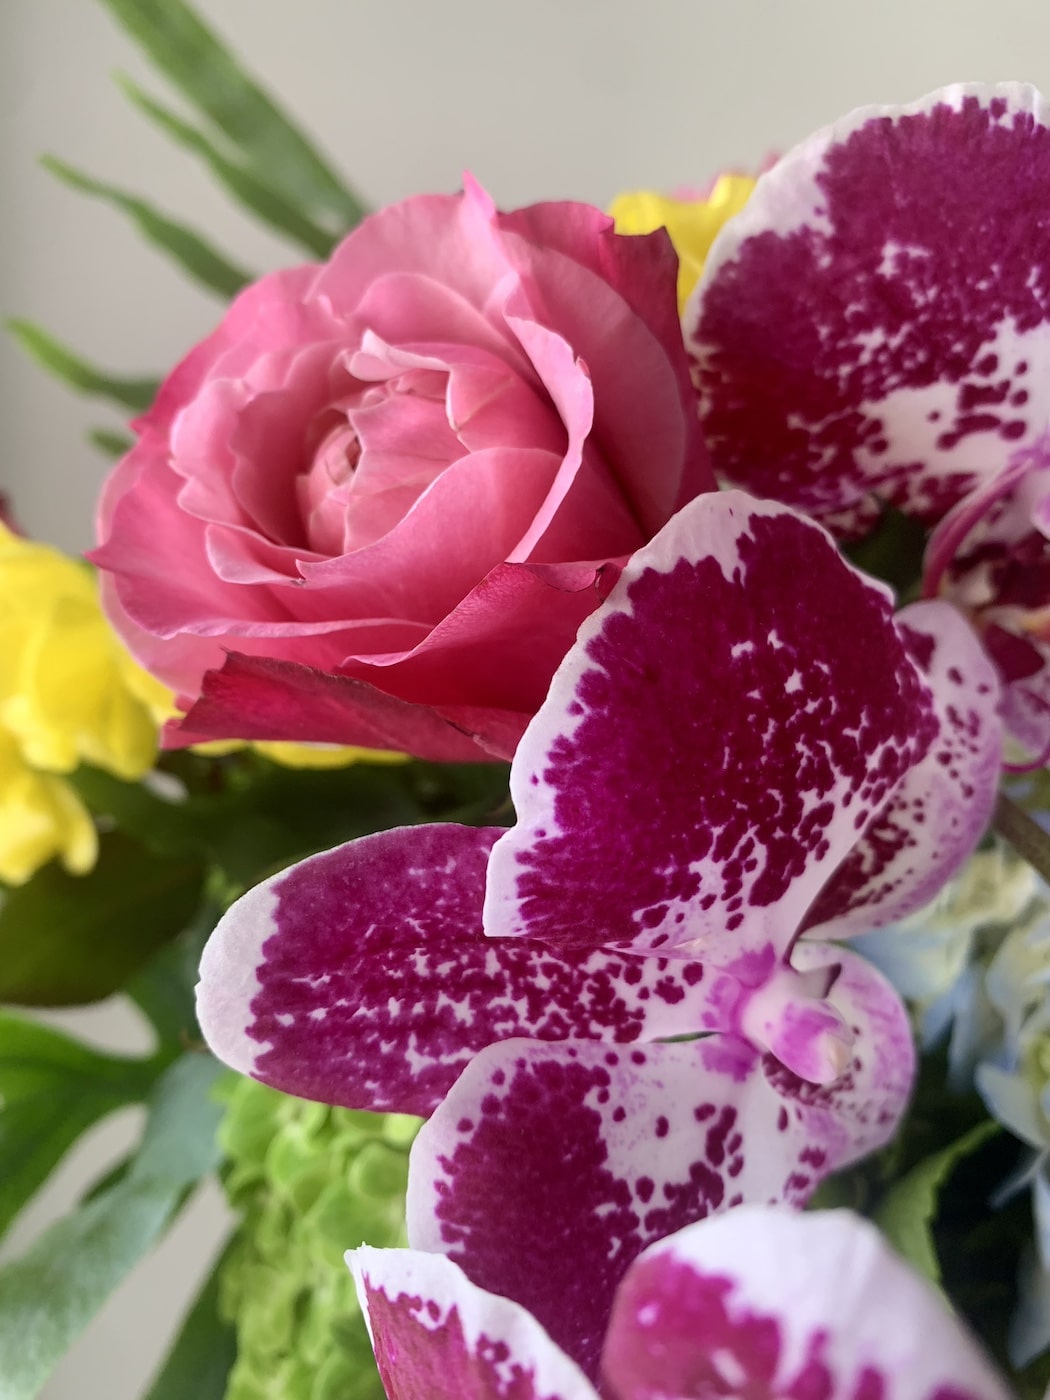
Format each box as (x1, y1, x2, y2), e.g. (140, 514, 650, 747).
(407, 946, 914, 1375)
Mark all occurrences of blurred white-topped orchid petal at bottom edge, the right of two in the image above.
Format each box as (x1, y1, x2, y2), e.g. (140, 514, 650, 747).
(602, 1205, 1009, 1400)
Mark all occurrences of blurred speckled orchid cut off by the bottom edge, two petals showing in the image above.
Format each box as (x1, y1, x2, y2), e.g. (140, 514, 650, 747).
(347, 1205, 1009, 1400)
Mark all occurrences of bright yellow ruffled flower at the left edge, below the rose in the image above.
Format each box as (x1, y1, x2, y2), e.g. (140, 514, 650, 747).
(0, 525, 164, 883)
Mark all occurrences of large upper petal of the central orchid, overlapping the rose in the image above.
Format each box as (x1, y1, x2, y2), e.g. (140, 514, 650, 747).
(484, 491, 937, 983)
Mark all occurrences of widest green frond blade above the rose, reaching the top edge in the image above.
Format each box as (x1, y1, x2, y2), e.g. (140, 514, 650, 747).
(95, 0, 365, 232)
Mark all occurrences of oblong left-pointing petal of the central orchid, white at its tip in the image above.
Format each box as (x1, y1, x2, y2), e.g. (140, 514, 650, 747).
(197, 823, 725, 1114)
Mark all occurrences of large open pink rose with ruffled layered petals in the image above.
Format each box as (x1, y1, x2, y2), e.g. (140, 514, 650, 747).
(94, 182, 713, 759)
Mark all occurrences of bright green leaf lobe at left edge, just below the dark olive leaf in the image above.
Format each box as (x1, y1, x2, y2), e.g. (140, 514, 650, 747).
(0, 1012, 157, 1233)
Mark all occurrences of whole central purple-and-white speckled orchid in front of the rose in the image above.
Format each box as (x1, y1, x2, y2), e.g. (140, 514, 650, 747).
(199, 491, 1000, 1373)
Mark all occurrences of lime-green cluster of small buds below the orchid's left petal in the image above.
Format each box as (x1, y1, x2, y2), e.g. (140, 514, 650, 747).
(220, 1079, 419, 1400)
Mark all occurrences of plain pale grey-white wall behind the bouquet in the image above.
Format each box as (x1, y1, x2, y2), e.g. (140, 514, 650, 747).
(0, 0, 1050, 1400)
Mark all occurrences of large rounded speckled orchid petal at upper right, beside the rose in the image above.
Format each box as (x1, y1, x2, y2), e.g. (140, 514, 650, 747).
(694, 84, 1050, 524)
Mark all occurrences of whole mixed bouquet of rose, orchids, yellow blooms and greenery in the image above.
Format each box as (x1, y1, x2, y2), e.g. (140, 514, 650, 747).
(0, 0, 1050, 1400)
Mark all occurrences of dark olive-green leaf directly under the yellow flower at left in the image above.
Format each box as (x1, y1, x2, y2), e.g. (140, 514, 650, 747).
(0, 832, 203, 1007)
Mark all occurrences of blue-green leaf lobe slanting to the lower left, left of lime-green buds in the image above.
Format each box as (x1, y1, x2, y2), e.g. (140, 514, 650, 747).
(0, 1054, 224, 1400)
